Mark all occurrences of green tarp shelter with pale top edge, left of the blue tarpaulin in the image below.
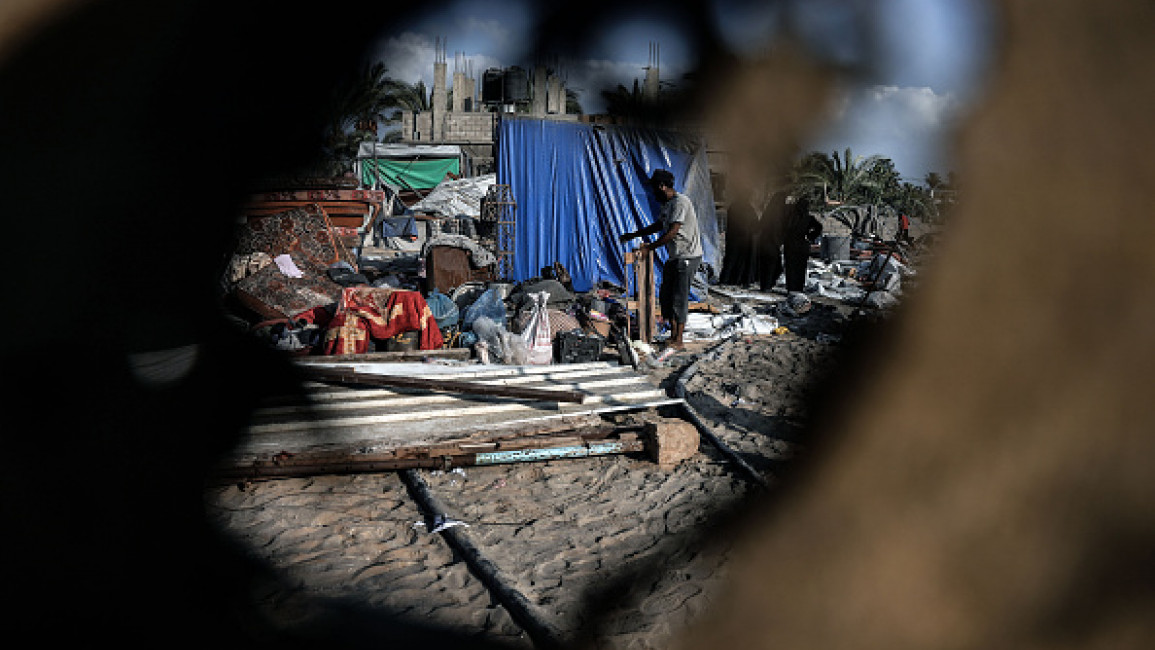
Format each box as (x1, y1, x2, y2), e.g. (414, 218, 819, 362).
(355, 142, 462, 190)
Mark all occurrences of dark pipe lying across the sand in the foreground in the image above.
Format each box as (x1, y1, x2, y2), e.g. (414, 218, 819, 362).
(401, 470, 567, 650)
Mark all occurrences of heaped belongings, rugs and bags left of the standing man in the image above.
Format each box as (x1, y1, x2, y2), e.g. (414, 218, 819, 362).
(221, 196, 631, 365)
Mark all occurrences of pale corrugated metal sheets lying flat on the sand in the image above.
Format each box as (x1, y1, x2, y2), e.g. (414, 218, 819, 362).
(234, 361, 681, 460)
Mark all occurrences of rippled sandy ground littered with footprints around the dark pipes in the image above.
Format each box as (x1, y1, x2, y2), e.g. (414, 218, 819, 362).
(207, 287, 859, 649)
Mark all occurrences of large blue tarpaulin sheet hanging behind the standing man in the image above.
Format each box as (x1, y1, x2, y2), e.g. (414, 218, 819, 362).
(497, 118, 718, 291)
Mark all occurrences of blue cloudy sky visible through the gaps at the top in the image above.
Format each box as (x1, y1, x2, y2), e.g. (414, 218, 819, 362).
(371, 0, 994, 181)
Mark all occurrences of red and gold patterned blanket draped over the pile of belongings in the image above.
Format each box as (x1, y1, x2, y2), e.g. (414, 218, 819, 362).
(323, 286, 442, 354)
